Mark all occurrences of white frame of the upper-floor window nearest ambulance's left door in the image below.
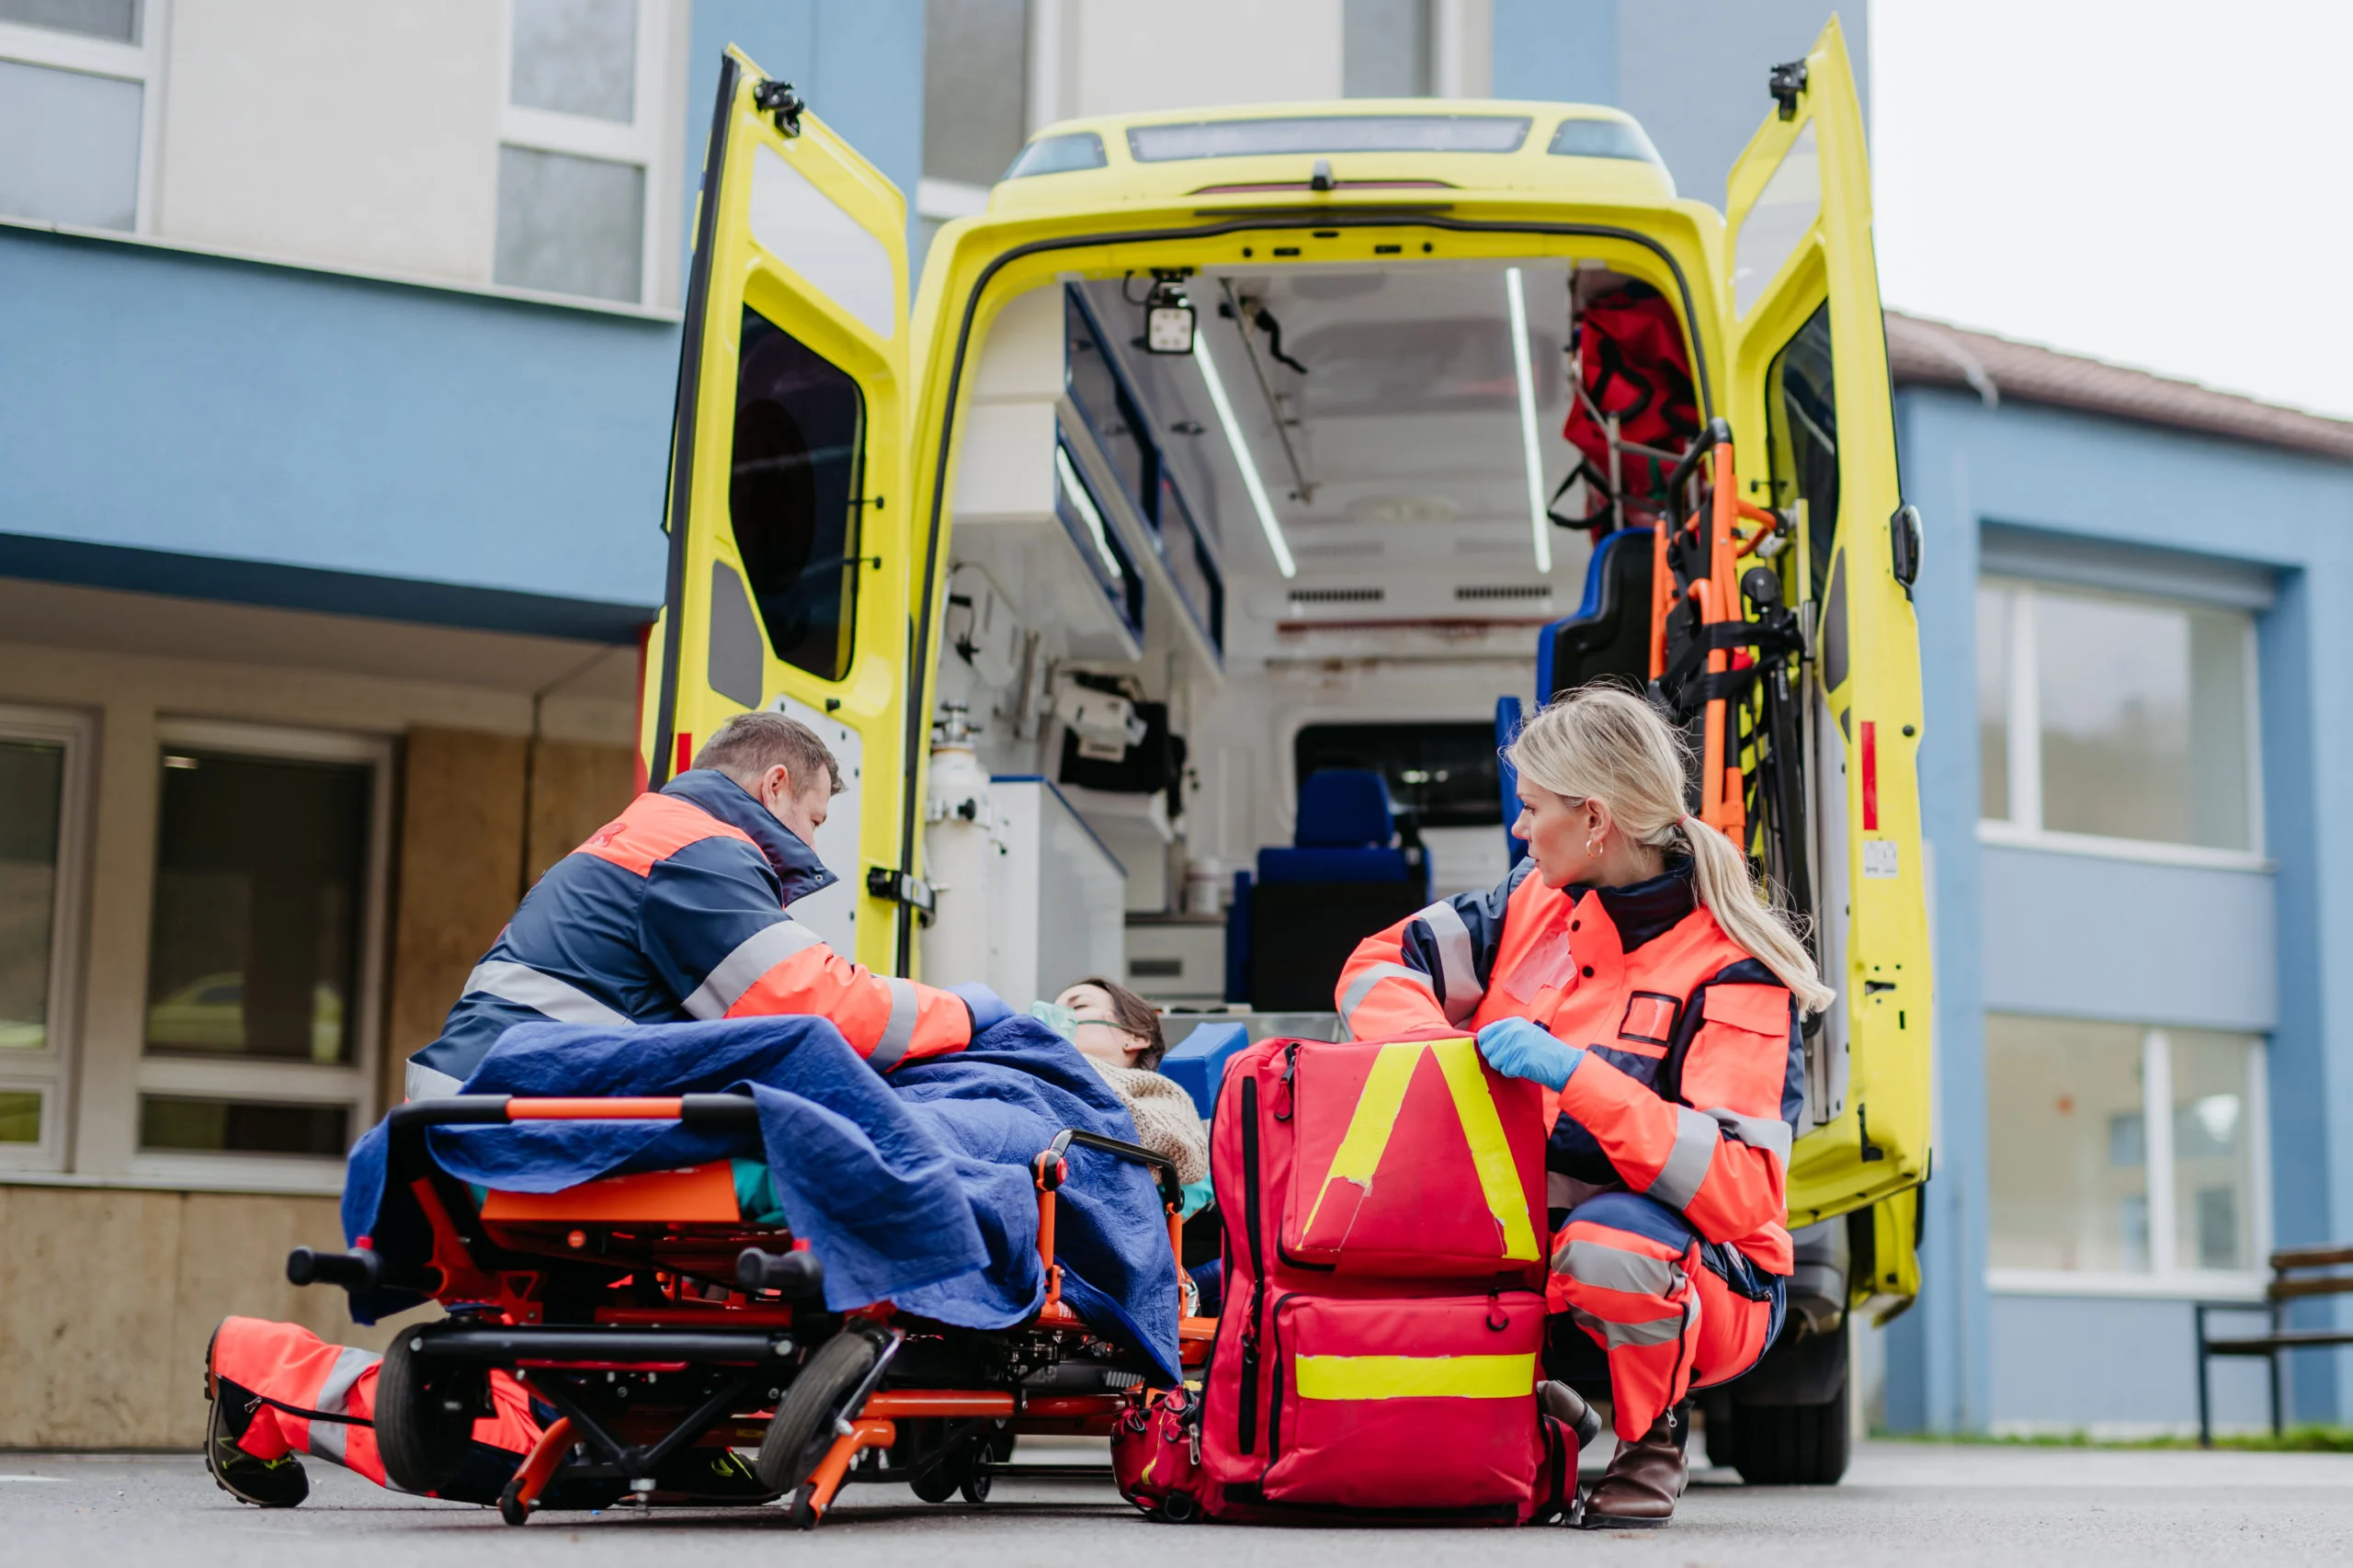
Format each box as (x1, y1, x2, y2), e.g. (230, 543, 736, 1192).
(484, 0, 673, 311)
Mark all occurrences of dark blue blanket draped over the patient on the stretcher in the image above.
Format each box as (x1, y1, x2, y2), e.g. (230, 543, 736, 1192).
(344, 1017, 1179, 1382)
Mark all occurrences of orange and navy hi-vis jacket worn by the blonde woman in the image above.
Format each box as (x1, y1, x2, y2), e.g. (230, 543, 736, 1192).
(1339, 859, 1805, 1274)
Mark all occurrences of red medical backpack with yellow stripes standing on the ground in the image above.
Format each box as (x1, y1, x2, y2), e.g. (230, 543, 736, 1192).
(1115, 1039, 1576, 1523)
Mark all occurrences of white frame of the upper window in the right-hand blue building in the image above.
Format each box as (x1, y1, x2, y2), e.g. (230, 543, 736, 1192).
(1976, 572, 2273, 871)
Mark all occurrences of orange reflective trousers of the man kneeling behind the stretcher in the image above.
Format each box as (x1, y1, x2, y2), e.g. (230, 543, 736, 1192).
(210, 1318, 539, 1502)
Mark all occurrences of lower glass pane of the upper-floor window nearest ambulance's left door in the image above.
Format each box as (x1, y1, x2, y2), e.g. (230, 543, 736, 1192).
(492, 146, 644, 303)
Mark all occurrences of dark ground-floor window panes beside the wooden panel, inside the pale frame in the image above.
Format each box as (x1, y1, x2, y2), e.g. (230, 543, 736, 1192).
(139, 725, 386, 1165)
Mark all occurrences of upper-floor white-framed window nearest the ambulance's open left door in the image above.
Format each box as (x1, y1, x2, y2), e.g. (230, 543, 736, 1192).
(492, 0, 665, 303)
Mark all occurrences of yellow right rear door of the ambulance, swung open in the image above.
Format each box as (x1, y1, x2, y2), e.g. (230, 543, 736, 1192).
(1722, 18, 1929, 1295)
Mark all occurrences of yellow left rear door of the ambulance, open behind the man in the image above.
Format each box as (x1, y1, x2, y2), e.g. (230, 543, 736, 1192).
(640, 50, 911, 972)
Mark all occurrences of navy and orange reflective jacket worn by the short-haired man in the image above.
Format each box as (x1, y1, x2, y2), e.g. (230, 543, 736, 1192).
(407, 767, 972, 1099)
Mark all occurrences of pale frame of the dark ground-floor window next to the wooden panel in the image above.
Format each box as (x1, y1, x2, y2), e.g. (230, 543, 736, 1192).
(120, 718, 395, 1194)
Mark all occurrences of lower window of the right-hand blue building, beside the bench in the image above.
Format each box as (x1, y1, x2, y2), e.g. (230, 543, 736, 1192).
(1986, 1012, 2268, 1288)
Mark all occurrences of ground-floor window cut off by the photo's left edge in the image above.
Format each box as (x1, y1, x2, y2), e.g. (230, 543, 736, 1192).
(0, 709, 89, 1170)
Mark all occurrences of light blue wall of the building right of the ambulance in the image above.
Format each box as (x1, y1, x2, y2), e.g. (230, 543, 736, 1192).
(1887, 389, 2353, 1429)
